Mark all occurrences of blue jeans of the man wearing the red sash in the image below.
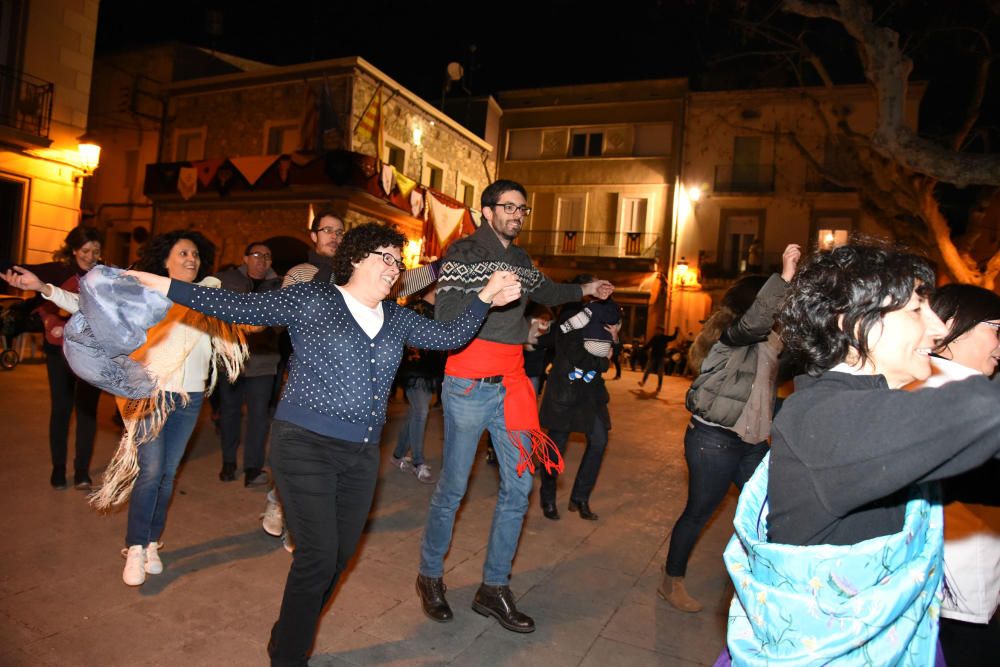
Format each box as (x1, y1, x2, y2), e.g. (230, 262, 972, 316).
(420, 375, 533, 586)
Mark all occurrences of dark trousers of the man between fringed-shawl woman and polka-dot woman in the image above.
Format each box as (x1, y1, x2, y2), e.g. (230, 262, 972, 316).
(218, 375, 274, 470)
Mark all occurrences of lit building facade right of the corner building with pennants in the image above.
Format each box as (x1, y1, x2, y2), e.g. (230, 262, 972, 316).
(498, 79, 687, 340)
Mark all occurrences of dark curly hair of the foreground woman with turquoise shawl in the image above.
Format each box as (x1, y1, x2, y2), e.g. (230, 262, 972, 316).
(779, 239, 934, 375)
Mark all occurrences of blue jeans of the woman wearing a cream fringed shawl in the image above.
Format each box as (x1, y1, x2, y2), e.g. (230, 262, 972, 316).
(125, 391, 204, 547)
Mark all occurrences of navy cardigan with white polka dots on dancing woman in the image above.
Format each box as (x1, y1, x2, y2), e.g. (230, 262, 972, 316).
(167, 280, 490, 444)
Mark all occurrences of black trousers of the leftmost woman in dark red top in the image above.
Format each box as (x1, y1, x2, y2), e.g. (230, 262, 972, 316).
(45, 345, 101, 475)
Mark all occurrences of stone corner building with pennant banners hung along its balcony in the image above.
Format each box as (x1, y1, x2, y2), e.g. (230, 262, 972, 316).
(145, 58, 495, 269)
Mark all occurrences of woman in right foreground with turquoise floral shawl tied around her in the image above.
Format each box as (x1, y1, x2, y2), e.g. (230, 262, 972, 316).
(724, 243, 1000, 665)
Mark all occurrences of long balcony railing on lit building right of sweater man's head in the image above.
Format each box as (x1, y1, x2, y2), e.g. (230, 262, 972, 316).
(517, 229, 660, 258)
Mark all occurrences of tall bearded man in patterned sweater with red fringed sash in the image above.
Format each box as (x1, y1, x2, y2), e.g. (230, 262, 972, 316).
(417, 180, 614, 632)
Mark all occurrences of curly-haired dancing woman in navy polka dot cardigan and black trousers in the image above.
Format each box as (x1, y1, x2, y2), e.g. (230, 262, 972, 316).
(129, 223, 521, 665)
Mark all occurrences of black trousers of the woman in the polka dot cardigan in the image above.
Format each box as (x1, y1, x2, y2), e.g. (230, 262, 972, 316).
(268, 420, 379, 666)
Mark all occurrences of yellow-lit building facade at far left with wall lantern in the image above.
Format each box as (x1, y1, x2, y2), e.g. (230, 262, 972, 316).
(0, 0, 99, 263)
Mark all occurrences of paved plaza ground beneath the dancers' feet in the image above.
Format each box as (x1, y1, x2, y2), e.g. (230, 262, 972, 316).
(0, 362, 735, 667)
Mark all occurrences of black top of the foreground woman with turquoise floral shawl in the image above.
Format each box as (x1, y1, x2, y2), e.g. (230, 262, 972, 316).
(767, 371, 1000, 545)
